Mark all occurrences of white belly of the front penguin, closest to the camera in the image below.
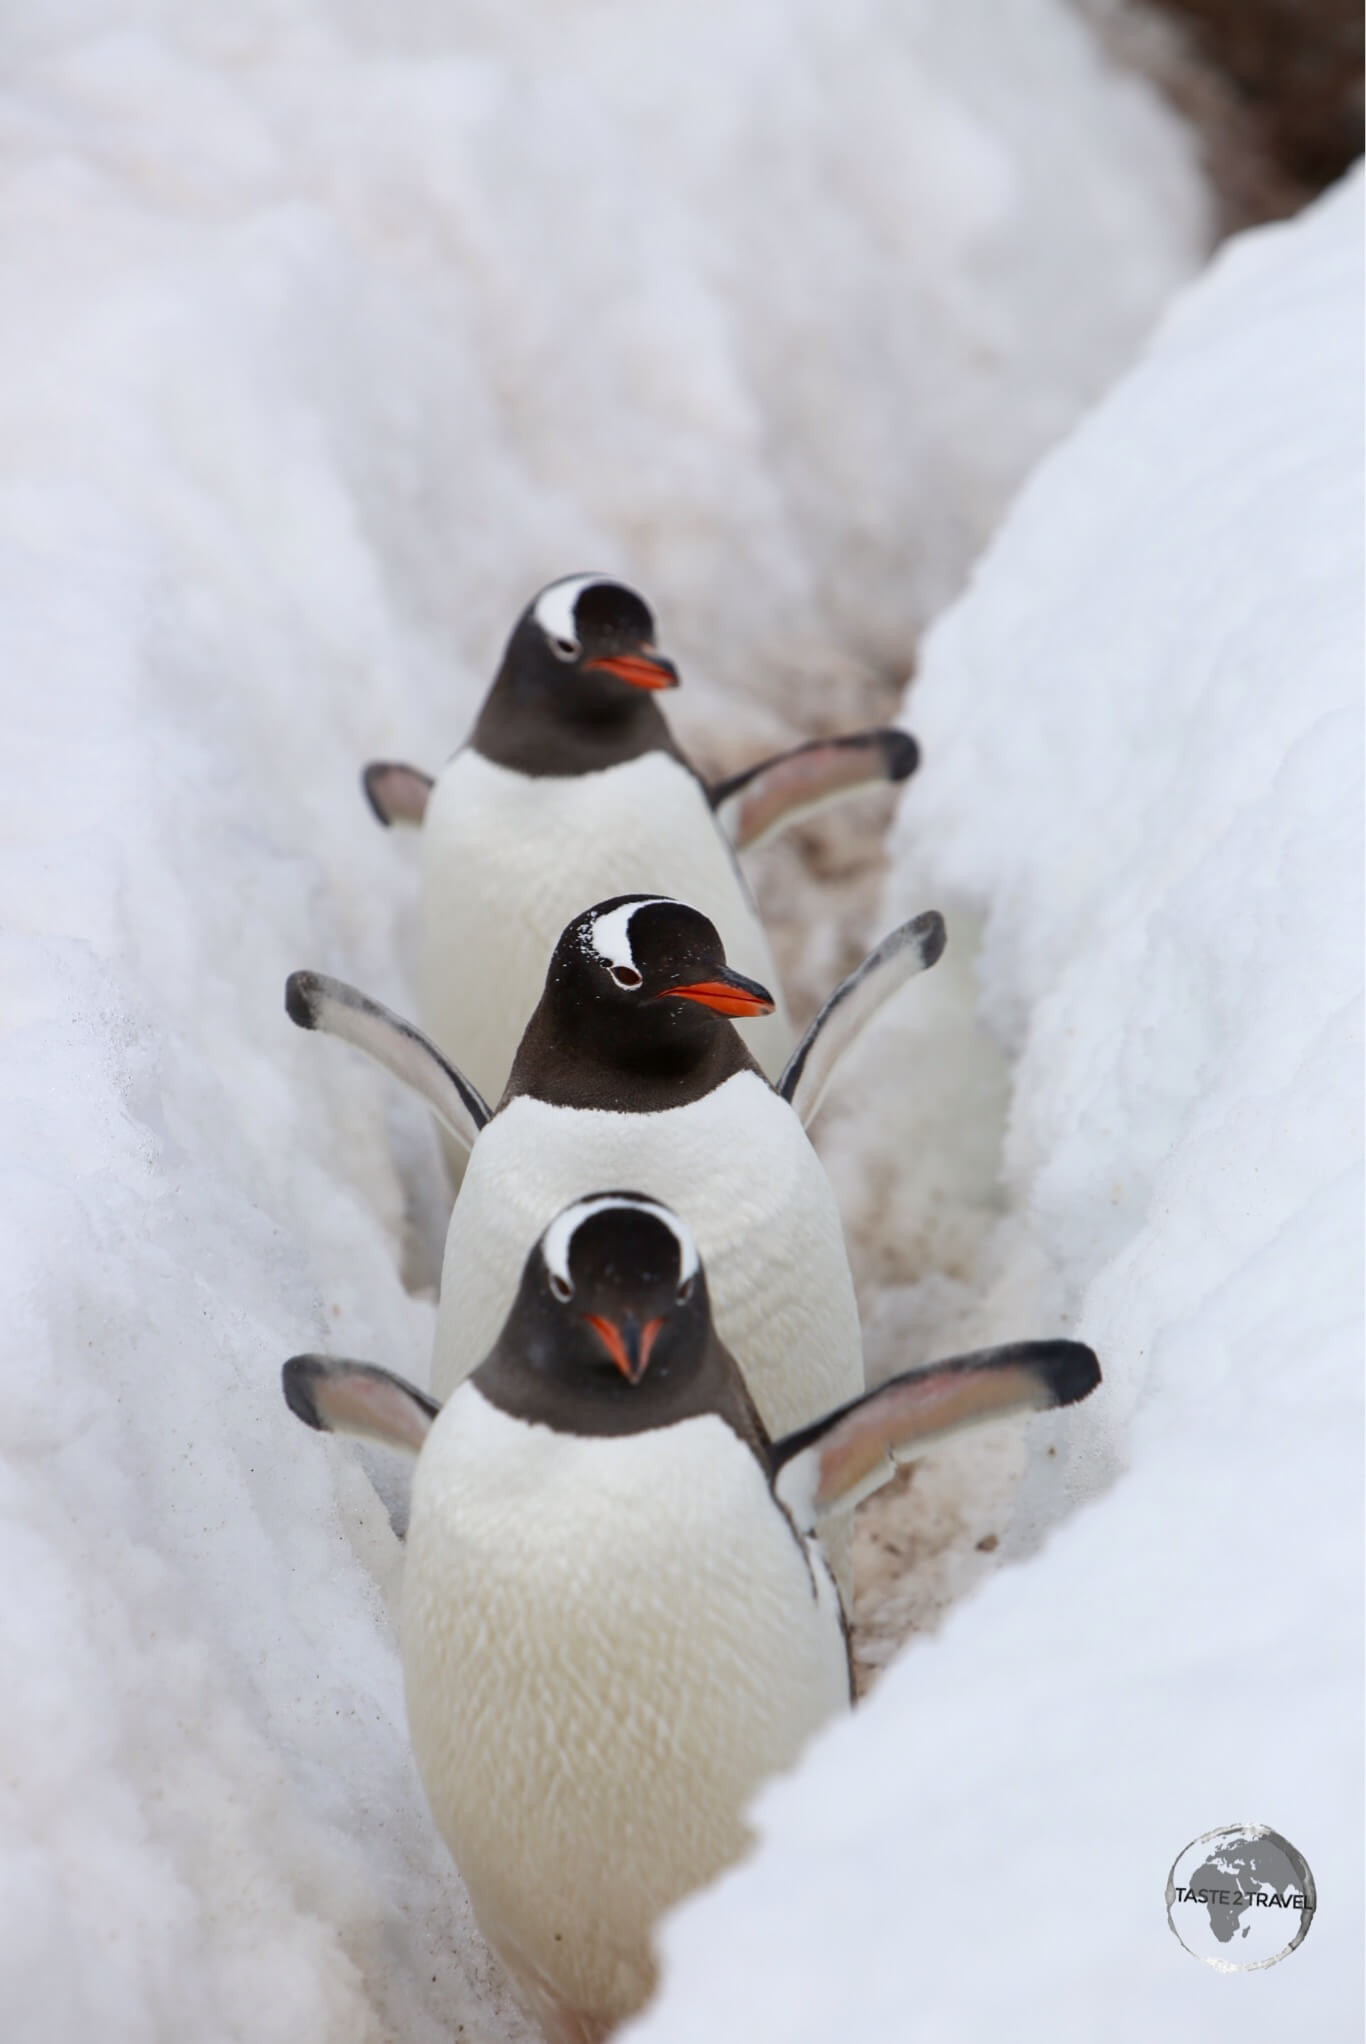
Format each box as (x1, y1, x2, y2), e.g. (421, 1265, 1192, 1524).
(403, 1384, 849, 2036)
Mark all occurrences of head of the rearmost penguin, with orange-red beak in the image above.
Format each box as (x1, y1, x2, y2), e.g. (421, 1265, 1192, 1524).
(503, 574, 679, 724)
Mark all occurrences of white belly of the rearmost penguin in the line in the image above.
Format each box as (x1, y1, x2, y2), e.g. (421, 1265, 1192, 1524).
(417, 750, 791, 1106)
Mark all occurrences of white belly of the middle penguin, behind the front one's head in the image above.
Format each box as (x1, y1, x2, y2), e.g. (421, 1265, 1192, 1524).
(431, 1071, 863, 1437)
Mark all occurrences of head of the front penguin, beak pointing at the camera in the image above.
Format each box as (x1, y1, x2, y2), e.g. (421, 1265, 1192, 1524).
(509, 1192, 712, 1416)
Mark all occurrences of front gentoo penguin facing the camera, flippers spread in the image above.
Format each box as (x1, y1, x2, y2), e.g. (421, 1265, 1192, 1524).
(284, 1194, 1100, 2044)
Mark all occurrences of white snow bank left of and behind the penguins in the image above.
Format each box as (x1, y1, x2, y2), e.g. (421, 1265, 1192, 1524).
(0, 0, 1202, 2044)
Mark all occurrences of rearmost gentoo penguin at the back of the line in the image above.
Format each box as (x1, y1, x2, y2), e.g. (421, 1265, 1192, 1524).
(364, 574, 918, 1120)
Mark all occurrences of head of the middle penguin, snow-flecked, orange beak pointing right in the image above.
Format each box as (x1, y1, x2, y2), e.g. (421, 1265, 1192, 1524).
(546, 895, 773, 1065)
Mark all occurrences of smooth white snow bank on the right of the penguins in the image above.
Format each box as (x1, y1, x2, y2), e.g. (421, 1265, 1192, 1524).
(630, 180, 1362, 2044)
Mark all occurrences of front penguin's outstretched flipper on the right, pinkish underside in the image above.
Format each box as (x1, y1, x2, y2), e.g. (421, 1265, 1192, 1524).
(771, 1341, 1100, 1531)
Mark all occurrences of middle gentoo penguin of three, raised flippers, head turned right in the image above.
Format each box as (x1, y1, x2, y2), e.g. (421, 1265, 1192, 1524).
(286, 895, 945, 1594)
